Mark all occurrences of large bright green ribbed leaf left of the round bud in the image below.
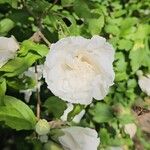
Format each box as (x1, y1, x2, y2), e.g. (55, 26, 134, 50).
(0, 96, 36, 130)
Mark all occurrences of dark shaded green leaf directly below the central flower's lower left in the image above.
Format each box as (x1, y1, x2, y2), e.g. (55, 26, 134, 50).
(44, 96, 67, 118)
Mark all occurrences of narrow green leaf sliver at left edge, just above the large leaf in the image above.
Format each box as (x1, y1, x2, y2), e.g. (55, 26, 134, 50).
(0, 79, 6, 106)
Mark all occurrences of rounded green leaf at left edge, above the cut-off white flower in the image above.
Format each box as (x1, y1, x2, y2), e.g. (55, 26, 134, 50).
(0, 18, 15, 36)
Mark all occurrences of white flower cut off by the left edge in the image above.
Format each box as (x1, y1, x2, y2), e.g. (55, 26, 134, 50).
(0, 36, 19, 68)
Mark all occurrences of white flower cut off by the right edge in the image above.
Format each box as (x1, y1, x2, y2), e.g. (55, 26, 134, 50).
(138, 75, 150, 96)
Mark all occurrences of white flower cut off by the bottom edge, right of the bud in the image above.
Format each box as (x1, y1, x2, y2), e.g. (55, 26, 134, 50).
(58, 127, 100, 150)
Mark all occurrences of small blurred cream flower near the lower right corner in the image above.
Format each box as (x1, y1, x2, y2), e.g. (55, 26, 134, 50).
(124, 123, 137, 138)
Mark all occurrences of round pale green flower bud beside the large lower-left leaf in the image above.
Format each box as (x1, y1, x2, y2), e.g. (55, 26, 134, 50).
(35, 119, 50, 135)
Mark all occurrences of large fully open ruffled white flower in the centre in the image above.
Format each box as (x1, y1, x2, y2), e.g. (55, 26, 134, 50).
(44, 36, 115, 105)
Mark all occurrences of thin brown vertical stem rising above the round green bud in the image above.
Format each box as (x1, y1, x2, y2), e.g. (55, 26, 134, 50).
(35, 63, 41, 120)
